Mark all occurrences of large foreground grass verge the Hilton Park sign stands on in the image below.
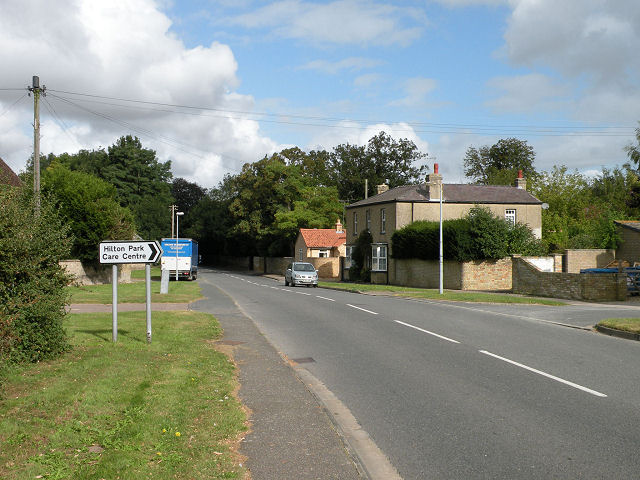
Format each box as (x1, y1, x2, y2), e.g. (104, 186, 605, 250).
(0, 312, 246, 480)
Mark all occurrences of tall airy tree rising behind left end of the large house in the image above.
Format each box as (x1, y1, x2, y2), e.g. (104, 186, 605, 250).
(330, 132, 427, 203)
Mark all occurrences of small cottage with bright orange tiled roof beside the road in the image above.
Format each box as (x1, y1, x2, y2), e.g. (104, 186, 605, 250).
(294, 220, 347, 262)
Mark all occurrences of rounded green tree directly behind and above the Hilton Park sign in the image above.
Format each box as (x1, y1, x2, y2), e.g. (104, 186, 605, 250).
(42, 163, 135, 263)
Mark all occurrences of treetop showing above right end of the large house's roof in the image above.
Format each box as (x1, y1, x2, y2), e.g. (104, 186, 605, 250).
(464, 138, 538, 185)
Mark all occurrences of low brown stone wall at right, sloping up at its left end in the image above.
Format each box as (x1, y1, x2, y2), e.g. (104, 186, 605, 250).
(512, 256, 627, 302)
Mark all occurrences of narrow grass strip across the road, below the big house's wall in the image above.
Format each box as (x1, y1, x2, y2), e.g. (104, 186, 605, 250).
(319, 282, 566, 306)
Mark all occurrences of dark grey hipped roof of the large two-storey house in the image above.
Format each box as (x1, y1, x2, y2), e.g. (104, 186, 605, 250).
(347, 183, 542, 208)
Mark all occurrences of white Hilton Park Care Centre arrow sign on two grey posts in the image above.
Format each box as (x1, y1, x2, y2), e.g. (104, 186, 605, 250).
(98, 240, 162, 343)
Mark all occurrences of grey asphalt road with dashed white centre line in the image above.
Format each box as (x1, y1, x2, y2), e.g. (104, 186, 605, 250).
(201, 271, 640, 479)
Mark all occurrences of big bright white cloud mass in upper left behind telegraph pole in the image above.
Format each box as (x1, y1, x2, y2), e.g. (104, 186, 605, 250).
(0, 0, 278, 187)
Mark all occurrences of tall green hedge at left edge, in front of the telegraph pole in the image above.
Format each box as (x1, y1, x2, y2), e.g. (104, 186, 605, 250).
(0, 188, 71, 362)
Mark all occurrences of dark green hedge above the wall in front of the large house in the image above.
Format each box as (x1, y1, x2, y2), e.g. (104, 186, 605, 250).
(391, 207, 544, 262)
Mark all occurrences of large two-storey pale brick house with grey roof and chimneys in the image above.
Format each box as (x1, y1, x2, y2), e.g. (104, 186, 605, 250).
(345, 164, 542, 283)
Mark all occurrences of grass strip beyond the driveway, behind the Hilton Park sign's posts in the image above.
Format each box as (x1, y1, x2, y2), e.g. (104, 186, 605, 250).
(67, 278, 203, 304)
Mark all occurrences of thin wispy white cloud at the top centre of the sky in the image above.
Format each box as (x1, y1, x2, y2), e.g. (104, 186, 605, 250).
(224, 0, 426, 46)
